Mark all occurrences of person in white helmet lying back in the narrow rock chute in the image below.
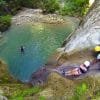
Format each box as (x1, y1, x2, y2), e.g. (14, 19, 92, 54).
(64, 61, 91, 76)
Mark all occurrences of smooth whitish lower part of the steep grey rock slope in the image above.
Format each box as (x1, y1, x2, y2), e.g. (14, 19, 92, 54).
(65, 27, 100, 53)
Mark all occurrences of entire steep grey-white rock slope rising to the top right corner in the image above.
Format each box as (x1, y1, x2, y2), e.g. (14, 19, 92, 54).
(62, 0, 100, 54)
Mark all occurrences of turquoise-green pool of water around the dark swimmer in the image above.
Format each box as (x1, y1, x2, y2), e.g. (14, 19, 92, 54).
(0, 23, 77, 81)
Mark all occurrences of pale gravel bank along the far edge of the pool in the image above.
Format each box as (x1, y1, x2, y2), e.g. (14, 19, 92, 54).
(12, 8, 64, 25)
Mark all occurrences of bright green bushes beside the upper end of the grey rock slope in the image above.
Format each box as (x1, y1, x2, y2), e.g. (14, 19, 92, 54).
(60, 0, 89, 16)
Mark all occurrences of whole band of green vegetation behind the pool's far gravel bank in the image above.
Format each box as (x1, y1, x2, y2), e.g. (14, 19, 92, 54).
(0, 0, 89, 31)
